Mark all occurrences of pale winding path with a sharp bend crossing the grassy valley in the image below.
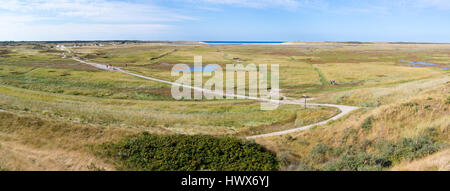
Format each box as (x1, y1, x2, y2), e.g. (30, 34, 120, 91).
(72, 57, 359, 139)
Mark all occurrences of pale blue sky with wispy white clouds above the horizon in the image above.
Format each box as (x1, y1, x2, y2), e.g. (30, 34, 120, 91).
(0, 0, 450, 42)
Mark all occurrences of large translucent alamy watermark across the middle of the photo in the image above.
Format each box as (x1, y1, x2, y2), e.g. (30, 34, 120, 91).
(171, 56, 280, 110)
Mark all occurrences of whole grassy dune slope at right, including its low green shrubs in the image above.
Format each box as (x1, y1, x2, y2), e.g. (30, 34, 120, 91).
(257, 80, 450, 170)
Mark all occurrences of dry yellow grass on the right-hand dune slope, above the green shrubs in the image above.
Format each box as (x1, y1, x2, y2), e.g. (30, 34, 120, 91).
(256, 80, 450, 168)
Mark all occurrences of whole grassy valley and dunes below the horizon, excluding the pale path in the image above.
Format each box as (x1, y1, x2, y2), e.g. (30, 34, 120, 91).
(0, 42, 450, 170)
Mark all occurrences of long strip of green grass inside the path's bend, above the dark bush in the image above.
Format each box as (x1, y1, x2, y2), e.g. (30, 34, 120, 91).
(0, 86, 310, 134)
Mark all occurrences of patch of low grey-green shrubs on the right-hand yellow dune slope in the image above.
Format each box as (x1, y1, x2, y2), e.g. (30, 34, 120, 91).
(309, 134, 440, 171)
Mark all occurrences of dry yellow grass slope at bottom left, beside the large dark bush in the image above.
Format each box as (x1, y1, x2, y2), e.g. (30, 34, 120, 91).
(0, 112, 133, 171)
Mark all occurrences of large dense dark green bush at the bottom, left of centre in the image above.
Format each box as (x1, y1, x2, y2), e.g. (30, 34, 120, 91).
(101, 133, 279, 171)
